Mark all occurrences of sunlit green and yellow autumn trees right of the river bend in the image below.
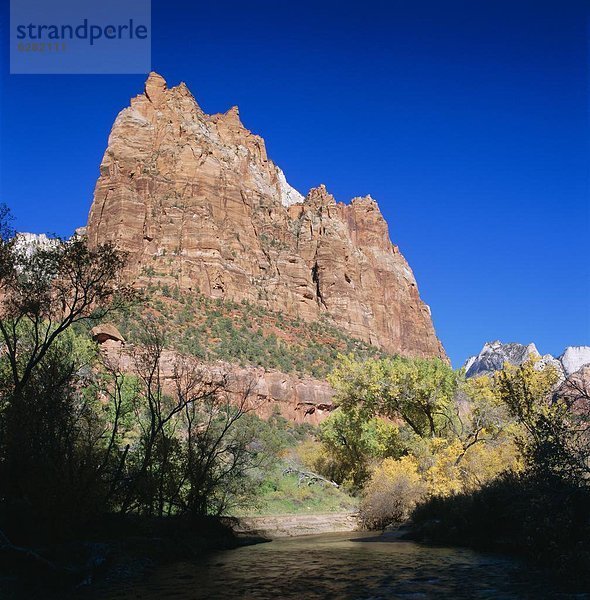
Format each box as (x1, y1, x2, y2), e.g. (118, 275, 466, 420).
(320, 357, 518, 518)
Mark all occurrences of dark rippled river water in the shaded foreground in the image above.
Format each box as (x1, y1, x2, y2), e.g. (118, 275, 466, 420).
(100, 533, 590, 600)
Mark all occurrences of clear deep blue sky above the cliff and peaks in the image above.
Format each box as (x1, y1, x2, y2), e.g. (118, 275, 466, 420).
(0, 0, 590, 366)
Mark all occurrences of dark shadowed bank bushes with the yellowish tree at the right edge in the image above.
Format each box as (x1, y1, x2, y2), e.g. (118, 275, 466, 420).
(414, 363, 590, 588)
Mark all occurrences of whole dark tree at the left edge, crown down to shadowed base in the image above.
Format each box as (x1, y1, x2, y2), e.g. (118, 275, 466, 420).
(0, 211, 128, 536)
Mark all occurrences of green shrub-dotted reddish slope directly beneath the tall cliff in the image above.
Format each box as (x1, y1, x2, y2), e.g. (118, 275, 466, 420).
(118, 285, 386, 379)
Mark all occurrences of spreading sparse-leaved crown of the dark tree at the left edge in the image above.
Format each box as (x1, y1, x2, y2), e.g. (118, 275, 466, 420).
(0, 232, 131, 402)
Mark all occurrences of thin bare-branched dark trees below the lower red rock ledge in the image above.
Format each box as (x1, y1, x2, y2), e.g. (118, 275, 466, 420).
(104, 319, 260, 516)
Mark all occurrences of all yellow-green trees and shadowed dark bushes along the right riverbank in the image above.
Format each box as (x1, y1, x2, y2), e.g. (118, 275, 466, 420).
(312, 358, 590, 583)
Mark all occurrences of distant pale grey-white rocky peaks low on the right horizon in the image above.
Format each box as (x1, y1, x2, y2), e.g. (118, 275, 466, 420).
(464, 340, 590, 378)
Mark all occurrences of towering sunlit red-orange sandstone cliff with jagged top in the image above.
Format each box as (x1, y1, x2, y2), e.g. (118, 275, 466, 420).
(87, 73, 446, 358)
